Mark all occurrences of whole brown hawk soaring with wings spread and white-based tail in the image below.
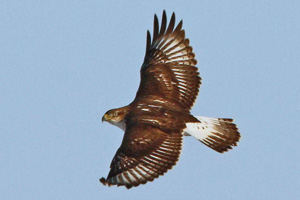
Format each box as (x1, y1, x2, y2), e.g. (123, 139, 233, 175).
(100, 11, 240, 189)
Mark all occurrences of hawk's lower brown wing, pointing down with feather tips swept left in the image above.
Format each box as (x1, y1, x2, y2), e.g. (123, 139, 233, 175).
(100, 124, 182, 189)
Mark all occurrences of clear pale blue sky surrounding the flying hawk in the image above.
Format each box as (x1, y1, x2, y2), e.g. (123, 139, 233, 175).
(0, 0, 300, 200)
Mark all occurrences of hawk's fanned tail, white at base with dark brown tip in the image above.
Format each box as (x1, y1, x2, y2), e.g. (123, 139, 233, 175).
(184, 116, 241, 153)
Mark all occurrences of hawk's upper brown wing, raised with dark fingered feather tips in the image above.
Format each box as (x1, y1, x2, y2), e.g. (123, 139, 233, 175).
(135, 11, 201, 110)
